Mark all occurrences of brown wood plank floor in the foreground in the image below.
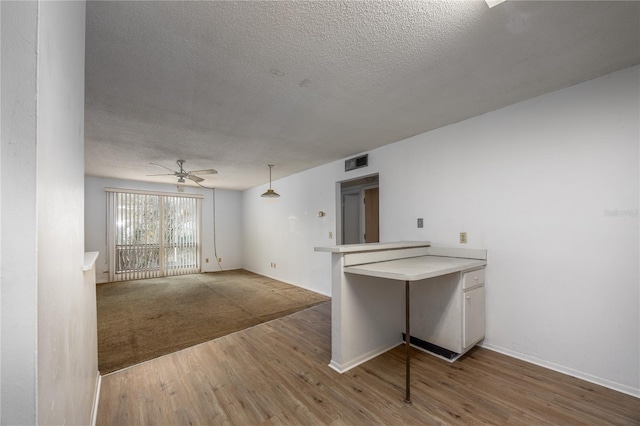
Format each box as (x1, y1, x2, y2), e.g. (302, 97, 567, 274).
(97, 302, 640, 425)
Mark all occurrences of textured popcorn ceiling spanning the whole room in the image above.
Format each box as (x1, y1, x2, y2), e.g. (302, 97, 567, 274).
(85, 0, 640, 190)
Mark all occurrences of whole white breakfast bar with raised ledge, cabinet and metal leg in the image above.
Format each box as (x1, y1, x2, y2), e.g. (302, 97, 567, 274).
(315, 241, 487, 403)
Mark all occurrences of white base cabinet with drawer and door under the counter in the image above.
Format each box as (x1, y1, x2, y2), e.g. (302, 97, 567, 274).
(411, 268, 485, 360)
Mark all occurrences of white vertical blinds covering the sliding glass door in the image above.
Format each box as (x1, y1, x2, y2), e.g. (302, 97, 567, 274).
(106, 188, 202, 281)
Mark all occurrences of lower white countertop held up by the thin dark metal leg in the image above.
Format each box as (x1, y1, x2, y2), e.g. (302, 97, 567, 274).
(344, 256, 487, 281)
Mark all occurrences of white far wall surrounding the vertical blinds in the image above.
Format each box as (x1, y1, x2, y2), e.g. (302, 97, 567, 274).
(85, 176, 242, 283)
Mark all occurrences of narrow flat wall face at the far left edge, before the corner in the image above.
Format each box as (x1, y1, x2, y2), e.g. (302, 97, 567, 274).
(0, 2, 37, 425)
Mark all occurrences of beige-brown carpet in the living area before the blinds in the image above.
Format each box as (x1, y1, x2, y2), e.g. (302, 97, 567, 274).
(96, 270, 330, 374)
